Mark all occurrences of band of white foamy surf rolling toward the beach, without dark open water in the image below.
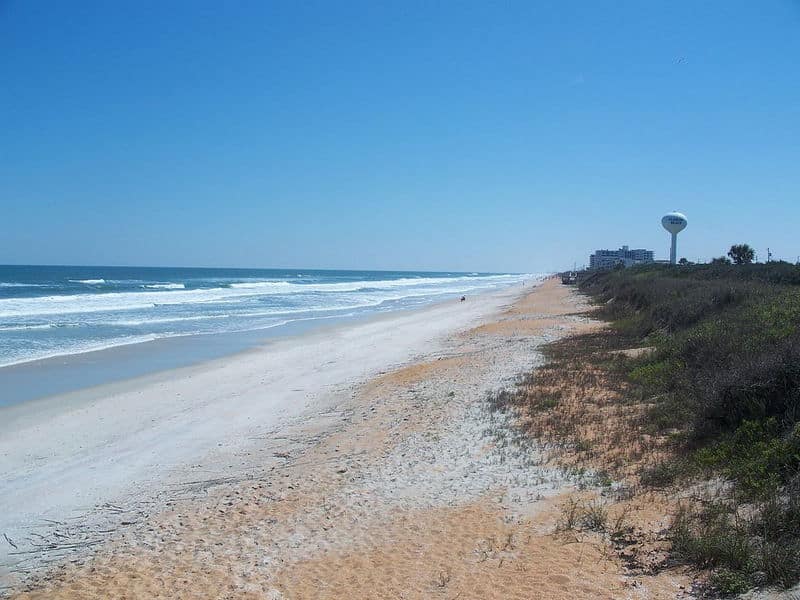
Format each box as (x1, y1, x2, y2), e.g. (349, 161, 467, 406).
(0, 275, 536, 366)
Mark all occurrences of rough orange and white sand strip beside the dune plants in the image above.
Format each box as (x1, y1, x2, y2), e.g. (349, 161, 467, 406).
(0, 279, 689, 600)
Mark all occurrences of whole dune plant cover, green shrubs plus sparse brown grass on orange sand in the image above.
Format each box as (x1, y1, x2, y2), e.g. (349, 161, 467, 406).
(492, 263, 800, 594)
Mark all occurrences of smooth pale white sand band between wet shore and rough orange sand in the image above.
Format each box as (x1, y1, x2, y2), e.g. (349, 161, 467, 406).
(0, 286, 530, 588)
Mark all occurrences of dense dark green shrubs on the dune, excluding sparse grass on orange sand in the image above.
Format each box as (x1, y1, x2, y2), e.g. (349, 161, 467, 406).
(581, 264, 800, 594)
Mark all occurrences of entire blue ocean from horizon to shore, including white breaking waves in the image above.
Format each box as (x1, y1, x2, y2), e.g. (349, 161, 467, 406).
(0, 266, 533, 368)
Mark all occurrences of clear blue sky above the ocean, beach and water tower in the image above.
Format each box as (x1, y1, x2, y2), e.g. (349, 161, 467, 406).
(0, 0, 800, 271)
